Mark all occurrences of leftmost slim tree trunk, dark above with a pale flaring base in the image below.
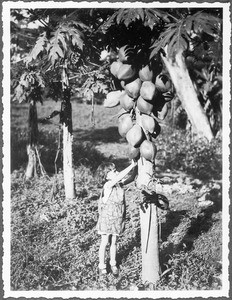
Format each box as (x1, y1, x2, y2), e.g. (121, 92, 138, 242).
(25, 100, 38, 179)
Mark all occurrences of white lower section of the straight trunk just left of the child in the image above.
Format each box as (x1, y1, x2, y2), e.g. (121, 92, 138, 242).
(63, 124, 76, 199)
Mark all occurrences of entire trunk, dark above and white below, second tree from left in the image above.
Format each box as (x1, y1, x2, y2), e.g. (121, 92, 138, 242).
(60, 66, 76, 199)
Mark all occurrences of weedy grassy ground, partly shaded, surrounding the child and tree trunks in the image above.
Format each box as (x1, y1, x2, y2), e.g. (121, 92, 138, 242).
(11, 101, 222, 290)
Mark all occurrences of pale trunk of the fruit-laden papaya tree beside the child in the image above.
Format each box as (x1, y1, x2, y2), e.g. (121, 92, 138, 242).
(137, 158, 160, 284)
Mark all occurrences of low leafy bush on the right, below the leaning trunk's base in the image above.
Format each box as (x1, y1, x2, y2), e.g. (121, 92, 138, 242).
(157, 129, 222, 180)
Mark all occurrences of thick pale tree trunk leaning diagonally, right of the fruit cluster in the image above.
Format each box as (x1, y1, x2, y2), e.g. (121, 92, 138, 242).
(162, 51, 213, 141)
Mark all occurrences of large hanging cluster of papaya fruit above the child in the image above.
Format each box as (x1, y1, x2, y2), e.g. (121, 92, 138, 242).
(104, 45, 172, 162)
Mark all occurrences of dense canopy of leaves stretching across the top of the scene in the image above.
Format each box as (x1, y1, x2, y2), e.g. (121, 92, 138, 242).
(11, 8, 222, 134)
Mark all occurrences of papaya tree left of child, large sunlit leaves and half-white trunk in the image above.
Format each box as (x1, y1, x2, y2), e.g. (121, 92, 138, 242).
(10, 10, 87, 198)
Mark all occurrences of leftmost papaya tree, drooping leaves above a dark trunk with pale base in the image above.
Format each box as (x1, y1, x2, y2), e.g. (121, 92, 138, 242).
(11, 10, 45, 179)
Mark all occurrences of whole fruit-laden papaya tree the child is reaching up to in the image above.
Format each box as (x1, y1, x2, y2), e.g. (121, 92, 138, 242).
(99, 8, 172, 284)
